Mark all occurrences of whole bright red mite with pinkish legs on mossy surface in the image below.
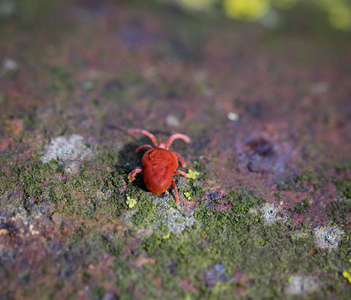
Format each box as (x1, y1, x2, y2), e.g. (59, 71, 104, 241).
(128, 129, 190, 203)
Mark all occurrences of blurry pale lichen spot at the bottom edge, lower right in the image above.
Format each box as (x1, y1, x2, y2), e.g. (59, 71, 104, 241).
(285, 275, 321, 295)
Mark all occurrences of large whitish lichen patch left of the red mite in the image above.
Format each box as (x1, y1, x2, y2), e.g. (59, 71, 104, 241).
(42, 134, 92, 173)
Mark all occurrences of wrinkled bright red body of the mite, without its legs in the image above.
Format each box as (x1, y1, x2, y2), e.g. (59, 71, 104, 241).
(142, 148, 178, 194)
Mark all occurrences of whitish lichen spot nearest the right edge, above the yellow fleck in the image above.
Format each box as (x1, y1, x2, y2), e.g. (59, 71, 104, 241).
(314, 226, 345, 249)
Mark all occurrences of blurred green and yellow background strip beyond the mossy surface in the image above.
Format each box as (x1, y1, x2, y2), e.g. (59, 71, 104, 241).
(0, 0, 351, 31)
